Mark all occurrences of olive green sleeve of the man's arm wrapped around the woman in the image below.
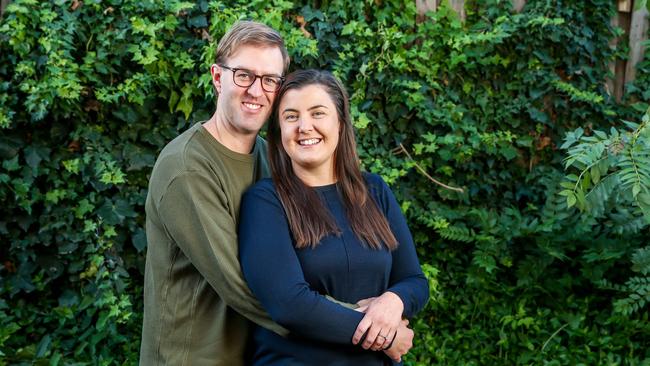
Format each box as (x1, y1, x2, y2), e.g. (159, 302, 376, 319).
(159, 171, 288, 335)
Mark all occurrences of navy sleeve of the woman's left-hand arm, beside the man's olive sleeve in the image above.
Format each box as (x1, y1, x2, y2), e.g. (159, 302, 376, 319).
(239, 185, 363, 344)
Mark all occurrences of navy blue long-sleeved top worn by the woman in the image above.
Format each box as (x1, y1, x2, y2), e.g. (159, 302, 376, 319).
(239, 174, 429, 365)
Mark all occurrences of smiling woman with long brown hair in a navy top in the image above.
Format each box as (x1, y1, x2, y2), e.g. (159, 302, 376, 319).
(239, 70, 428, 365)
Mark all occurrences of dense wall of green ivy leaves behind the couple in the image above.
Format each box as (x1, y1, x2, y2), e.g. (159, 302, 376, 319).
(0, 0, 650, 365)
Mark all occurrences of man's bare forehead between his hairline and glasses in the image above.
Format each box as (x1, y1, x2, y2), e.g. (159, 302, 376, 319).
(227, 45, 284, 75)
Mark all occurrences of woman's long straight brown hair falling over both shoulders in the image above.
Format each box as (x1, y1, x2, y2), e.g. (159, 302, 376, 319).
(267, 70, 398, 250)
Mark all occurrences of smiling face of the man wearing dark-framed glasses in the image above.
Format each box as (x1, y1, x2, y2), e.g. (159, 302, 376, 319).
(211, 45, 284, 135)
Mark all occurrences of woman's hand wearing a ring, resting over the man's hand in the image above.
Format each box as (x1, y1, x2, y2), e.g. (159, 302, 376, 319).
(352, 291, 404, 351)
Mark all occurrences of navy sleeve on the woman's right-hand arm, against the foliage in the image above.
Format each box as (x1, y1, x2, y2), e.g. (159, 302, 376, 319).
(371, 174, 429, 318)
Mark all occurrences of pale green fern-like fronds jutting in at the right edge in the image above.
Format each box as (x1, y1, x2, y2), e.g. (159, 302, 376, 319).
(559, 108, 650, 226)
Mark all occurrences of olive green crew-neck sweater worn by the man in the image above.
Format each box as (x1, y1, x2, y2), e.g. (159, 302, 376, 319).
(140, 123, 286, 366)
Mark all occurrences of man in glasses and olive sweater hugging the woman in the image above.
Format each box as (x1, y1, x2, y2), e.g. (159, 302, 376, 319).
(140, 21, 289, 366)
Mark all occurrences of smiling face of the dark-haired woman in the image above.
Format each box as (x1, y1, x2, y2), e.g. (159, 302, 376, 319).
(278, 85, 340, 180)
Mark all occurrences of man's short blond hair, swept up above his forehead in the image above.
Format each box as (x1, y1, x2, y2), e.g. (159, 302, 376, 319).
(215, 20, 289, 74)
